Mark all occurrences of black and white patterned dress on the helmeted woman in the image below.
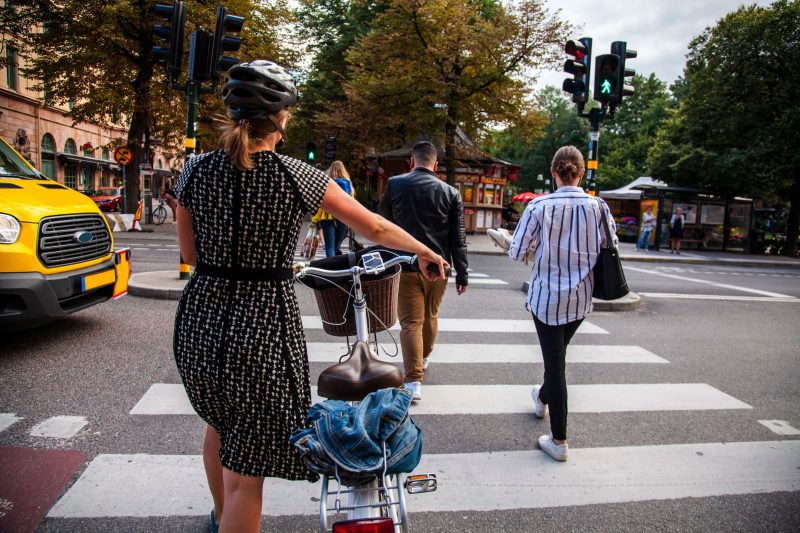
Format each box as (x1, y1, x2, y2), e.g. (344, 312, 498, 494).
(173, 150, 328, 480)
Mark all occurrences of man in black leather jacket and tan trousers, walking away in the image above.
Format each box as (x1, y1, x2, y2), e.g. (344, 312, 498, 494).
(379, 141, 468, 400)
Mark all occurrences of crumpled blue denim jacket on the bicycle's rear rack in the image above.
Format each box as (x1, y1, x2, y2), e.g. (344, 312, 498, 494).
(289, 389, 422, 484)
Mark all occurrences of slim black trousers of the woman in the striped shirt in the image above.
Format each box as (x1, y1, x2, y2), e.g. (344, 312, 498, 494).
(533, 316, 583, 440)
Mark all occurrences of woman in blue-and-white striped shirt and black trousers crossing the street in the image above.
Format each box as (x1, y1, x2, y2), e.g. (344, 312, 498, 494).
(508, 146, 616, 461)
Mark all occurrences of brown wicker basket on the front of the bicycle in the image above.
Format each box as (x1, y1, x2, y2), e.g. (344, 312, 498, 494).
(314, 267, 400, 337)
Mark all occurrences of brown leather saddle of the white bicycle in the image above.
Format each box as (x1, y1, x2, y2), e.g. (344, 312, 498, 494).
(317, 341, 403, 402)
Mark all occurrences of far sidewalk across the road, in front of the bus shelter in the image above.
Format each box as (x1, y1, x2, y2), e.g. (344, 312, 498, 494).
(467, 233, 800, 268)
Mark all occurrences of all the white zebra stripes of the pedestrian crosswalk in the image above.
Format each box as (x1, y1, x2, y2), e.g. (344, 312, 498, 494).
(21, 316, 800, 530)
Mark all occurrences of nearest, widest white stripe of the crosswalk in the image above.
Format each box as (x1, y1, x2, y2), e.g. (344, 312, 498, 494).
(48, 438, 800, 518)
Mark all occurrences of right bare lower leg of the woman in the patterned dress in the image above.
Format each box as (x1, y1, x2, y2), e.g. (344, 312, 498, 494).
(219, 468, 264, 533)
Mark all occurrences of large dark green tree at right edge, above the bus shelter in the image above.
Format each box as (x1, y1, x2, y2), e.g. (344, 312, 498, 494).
(649, 0, 800, 255)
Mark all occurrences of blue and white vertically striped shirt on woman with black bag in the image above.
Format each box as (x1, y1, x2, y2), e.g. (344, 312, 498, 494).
(508, 186, 617, 326)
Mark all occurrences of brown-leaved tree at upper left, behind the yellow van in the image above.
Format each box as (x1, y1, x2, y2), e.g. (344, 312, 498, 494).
(0, 0, 288, 212)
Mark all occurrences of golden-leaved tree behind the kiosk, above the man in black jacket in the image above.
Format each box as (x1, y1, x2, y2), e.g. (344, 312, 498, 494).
(328, 0, 568, 184)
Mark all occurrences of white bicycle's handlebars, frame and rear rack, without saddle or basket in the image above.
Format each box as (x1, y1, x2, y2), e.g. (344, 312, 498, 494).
(295, 251, 437, 533)
